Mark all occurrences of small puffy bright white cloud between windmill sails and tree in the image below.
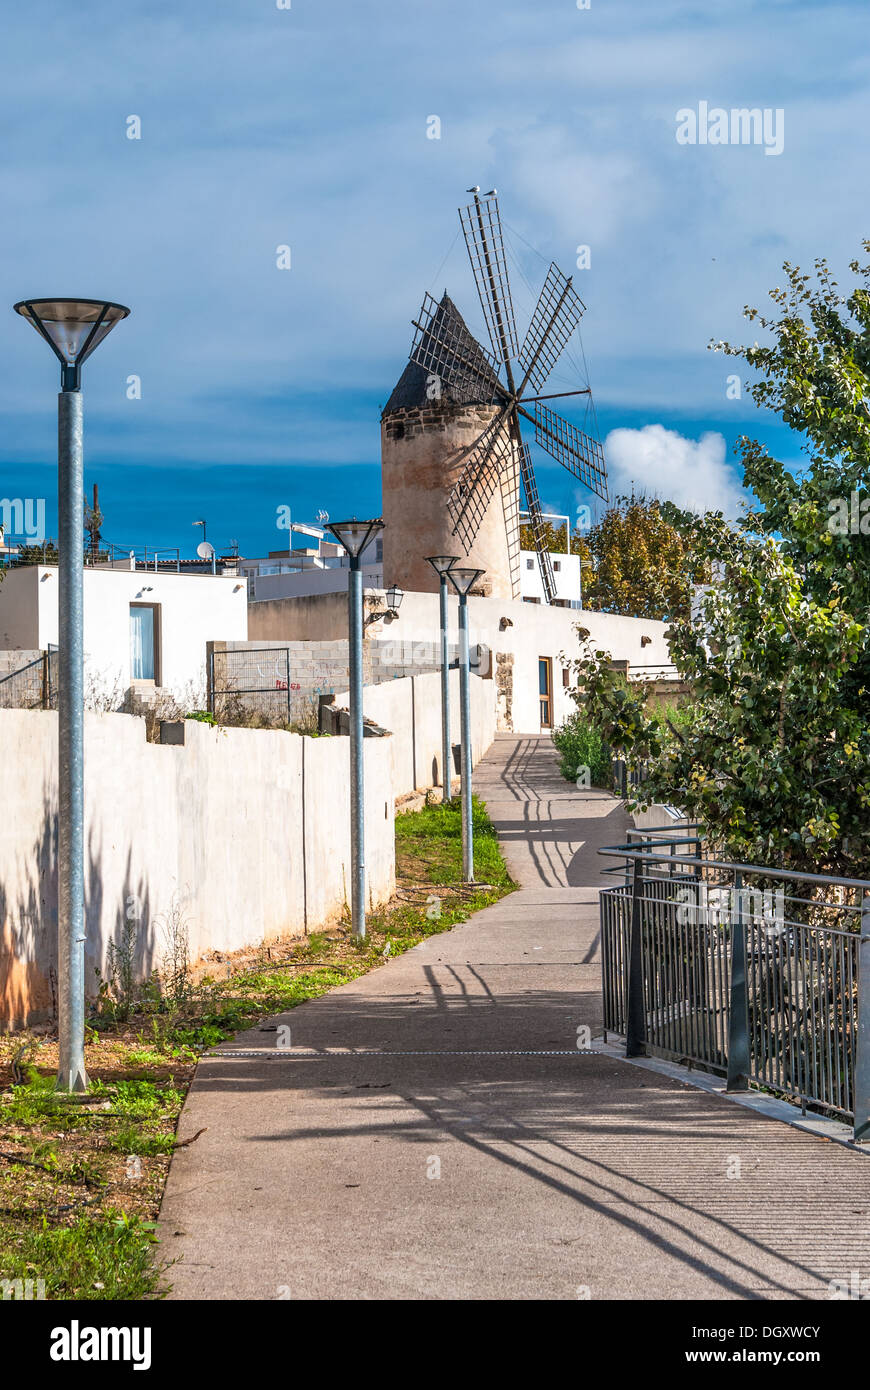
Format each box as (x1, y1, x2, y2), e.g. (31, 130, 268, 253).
(605, 425, 746, 517)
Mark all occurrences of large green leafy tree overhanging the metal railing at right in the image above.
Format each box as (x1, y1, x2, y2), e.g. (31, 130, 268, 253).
(567, 245, 870, 877)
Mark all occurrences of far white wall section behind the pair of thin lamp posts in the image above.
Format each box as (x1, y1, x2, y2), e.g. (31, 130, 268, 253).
(335, 671, 496, 796)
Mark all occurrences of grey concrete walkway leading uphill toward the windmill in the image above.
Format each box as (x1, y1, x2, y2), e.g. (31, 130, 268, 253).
(161, 735, 870, 1300)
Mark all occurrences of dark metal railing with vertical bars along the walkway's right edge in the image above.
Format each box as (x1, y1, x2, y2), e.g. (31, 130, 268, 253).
(599, 826, 870, 1138)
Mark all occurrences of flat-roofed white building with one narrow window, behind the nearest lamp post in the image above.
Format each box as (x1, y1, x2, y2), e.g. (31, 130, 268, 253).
(0, 564, 247, 705)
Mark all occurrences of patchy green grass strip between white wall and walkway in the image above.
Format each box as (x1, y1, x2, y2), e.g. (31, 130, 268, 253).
(0, 799, 516, 1300)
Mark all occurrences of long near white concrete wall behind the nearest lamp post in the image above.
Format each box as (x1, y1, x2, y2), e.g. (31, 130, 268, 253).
(0, 710, 395, 1026)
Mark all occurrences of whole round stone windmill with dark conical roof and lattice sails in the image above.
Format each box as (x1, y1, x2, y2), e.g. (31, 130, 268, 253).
(381, 189, 607, 602)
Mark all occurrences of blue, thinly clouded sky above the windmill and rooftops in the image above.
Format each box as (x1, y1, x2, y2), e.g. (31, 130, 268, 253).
(0, 0, 870, 555)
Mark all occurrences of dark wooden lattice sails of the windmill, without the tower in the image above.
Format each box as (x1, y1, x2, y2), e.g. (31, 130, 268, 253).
(410, 188, 607, 603)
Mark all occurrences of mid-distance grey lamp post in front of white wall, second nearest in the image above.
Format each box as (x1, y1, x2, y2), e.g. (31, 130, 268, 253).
(327, 518, 384, 941)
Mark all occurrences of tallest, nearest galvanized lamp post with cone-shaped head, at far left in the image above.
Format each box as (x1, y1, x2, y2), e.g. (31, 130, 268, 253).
(14, 299, 129, 1091)
